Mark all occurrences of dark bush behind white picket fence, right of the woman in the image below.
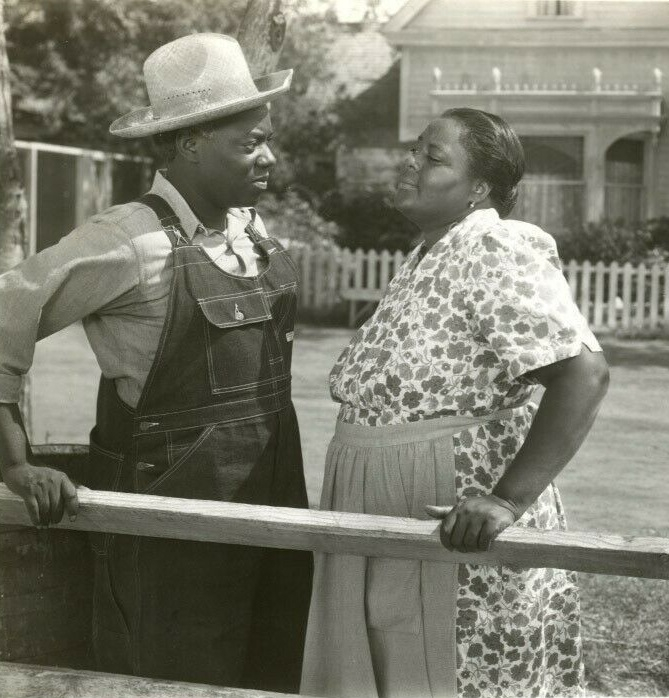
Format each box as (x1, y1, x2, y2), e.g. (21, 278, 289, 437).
(557, 218, 669, 264)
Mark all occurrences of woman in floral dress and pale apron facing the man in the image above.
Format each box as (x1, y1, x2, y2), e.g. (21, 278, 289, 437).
(302, 109, 608, 698)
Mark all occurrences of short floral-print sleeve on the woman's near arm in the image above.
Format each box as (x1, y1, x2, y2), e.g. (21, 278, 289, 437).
(467, 229, 601, 382)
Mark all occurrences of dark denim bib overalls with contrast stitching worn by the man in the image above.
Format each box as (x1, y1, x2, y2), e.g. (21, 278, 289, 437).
(85, 194, 312, 692)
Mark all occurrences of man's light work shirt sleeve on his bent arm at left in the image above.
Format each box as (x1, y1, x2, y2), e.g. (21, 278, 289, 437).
(0, 219, 139, 402)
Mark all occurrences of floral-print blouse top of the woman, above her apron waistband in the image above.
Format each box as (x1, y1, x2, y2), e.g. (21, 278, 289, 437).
(330, 209, 601, 426)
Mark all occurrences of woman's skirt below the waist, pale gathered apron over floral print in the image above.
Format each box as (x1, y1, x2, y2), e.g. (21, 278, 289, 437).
(301, 407, 582, 698)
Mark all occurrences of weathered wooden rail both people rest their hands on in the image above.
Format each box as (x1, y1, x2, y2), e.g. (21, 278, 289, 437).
(0, 485, 669, 579)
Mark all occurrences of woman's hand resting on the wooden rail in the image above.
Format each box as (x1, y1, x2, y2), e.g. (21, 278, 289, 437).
(425, 494, 520, 553)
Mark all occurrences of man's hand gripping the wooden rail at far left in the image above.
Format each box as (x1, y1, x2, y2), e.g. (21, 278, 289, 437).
(3, 463, 79, 526)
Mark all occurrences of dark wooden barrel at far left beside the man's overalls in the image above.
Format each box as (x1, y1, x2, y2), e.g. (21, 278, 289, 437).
(0, 444, 93, 669)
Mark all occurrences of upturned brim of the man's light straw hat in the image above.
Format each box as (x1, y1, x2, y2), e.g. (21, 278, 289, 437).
(109, 70, 293, 138)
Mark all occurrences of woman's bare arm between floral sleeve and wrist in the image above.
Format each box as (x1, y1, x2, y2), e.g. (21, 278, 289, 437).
(493, 349, 608, 512)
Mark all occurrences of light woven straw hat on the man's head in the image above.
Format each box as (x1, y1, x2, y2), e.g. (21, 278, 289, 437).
(109, 34, 293, 138)
